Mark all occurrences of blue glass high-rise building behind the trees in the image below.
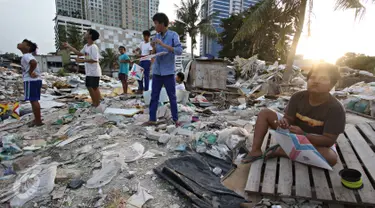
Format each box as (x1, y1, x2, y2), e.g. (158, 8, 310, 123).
(200, 0, 259, 57)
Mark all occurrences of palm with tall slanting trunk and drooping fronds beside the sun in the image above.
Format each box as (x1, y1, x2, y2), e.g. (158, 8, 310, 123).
(233, 0, 375, 82)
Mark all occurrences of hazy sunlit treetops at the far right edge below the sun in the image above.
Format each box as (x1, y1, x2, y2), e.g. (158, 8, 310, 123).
(336, 53, 375, 73)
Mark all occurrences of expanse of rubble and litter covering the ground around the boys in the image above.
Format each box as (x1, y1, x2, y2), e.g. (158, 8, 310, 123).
(0, 57, 370, 208)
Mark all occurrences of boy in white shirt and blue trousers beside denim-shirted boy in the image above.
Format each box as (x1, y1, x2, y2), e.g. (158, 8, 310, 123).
(135, 30, 152, 94)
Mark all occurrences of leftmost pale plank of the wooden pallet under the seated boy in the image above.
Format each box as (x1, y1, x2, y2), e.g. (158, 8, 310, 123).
(245, 132, 270, 193)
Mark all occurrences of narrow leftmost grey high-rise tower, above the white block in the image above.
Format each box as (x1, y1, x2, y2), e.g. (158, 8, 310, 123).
(55, 0, 86, 19)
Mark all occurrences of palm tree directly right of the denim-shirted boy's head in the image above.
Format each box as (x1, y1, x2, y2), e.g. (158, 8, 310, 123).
(175, 0, 217, 59)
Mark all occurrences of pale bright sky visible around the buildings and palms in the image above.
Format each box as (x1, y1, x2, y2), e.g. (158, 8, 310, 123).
(0, 0, 375, 63)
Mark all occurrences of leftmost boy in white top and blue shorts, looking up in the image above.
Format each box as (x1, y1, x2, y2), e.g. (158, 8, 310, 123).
(17, 39, 43, 127)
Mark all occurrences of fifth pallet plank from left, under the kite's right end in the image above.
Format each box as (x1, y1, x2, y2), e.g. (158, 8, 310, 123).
(311, 167, 332, 200)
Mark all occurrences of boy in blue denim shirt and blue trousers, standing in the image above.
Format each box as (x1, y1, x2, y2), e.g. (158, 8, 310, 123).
(145, 13, 182, 125)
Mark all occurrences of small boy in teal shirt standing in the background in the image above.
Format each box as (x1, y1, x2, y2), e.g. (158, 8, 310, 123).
(118, 46, 131, 95)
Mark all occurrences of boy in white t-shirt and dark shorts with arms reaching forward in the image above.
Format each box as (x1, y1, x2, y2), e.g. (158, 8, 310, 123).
(64, 29, 104, 112)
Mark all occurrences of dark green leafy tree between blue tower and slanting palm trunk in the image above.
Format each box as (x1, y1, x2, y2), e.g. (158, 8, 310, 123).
(219, 1, 293, 62)
